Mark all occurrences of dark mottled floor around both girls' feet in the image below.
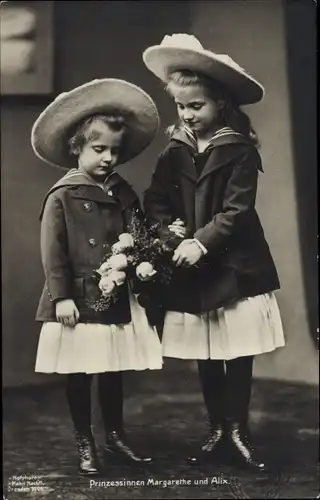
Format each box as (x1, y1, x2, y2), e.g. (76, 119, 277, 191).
(3, 364, 319, 500)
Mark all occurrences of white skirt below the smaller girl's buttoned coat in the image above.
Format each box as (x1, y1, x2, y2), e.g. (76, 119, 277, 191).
(35, 293, 163, 373)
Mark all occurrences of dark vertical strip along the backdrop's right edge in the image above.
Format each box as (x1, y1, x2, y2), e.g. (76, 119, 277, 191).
(285, 1, 319, 347)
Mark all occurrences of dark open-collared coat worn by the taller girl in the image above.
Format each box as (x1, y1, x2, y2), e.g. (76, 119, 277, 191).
(144, 132, 280, 313)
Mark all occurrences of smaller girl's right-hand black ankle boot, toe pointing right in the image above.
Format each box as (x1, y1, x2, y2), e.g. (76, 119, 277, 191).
(104, 430, 152, 465)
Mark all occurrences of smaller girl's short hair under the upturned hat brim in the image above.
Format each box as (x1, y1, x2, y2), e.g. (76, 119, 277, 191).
(68, 114, 128, 155)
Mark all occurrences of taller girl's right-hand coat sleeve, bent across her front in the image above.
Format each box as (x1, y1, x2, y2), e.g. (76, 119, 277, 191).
(194, 149, 260, 253)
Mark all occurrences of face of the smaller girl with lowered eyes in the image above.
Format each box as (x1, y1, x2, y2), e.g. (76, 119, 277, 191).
(78, 120, 123, 182)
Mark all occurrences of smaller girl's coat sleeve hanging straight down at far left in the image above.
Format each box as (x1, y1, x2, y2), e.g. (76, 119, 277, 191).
(40, 193, 72, 301)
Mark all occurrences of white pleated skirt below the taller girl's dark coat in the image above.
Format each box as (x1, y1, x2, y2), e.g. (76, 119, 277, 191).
(162, 293, 285, 360)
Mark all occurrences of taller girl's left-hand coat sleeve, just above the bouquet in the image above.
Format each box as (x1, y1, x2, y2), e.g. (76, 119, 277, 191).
(143, 150, 181, 248)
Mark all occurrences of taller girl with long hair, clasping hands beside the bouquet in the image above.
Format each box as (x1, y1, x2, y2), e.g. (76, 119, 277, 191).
(143, 34, 284, 469)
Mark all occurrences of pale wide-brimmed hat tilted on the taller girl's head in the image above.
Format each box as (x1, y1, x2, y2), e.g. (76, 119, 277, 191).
(143, 33, 264, 105)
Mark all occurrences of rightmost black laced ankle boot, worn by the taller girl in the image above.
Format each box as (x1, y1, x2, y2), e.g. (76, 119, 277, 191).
(226, 421, 266, 471)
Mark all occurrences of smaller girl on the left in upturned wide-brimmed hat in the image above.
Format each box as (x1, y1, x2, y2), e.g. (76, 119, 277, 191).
(31, 79, 162, 475)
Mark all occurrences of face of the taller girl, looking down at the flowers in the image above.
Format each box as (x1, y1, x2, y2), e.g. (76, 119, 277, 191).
(169, 82, 222, 138)
